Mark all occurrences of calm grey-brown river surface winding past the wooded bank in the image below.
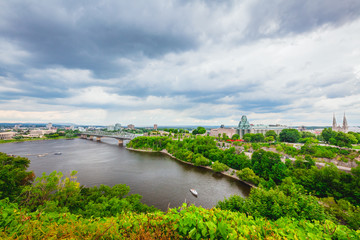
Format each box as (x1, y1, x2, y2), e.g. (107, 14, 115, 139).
(0, 138, 250, 210)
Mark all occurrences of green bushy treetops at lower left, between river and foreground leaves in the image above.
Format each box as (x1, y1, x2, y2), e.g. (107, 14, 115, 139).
(19, 171, 155, 217)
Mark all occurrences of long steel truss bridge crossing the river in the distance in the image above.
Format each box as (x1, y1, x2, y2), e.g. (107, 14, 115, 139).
(79, 131, 143, 146)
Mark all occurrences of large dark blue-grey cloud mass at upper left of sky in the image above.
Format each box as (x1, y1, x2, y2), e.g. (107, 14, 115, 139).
(0, 1, 197, 77)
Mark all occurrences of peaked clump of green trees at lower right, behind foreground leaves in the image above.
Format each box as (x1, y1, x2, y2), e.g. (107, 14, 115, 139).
(217, 178, 328, 220)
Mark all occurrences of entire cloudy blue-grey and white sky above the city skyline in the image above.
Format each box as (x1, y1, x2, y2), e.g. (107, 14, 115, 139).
(0, 0, 360, 126)
